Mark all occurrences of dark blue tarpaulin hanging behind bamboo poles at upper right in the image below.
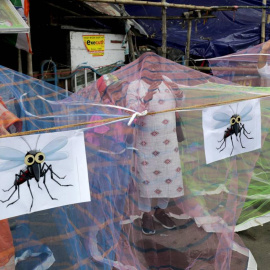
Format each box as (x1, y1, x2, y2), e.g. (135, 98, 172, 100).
(126, 0, 270, 58)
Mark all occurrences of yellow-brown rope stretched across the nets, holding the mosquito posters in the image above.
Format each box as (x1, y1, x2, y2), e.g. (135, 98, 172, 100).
(0, 95, 270, 138)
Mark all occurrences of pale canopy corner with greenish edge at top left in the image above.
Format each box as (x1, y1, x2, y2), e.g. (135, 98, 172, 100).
(0, 0, 29, 34)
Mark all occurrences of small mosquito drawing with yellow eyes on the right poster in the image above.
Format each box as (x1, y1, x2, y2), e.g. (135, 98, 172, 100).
(213, 104, 253, 155)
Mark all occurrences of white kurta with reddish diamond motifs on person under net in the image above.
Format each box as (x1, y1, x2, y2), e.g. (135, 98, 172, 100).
(127, 80, 184, 198)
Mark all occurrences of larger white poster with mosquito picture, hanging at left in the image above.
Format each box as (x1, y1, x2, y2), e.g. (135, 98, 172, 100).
(0, 131, 90, 220)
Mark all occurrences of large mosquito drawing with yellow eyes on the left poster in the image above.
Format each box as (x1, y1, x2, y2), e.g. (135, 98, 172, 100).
(0, 136, 72, 212)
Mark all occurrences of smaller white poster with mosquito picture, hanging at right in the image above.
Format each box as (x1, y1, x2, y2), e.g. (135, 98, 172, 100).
(203, 99, 261, 164)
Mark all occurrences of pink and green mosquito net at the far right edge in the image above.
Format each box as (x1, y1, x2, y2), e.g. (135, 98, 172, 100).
(209, 43, 270, 231)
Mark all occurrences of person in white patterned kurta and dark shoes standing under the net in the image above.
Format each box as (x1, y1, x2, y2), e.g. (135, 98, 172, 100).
(126, 65, 184, 234)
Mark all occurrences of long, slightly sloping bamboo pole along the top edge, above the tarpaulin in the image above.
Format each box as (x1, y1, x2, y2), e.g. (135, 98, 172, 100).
(81, 0, 214, 10)
